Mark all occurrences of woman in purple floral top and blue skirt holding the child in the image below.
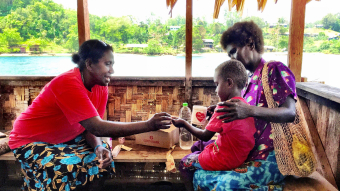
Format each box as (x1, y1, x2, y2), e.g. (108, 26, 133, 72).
(194, 21, 297, 190)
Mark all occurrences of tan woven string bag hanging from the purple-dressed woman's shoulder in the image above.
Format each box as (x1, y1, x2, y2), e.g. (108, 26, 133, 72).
(262, 63, 316, 177)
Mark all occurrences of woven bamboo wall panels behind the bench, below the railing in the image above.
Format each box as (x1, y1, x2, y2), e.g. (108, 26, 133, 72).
(0, 77, 218, 130)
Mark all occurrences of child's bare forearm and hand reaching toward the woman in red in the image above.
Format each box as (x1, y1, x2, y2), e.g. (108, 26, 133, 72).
(172, 117, 215, 141)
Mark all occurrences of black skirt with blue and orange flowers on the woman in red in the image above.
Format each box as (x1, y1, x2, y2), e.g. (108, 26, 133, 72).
(12, 135, 115, 190)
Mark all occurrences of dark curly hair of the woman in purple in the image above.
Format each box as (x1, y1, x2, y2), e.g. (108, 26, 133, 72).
(220, 21, 264, 54)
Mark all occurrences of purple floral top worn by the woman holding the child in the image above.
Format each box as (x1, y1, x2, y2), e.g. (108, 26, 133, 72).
(243, 59, 297, 161)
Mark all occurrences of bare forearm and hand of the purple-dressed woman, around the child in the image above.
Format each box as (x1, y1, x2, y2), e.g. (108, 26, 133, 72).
(217, 96, 296, 123)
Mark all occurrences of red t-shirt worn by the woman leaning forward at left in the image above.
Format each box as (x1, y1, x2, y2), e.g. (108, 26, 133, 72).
(8, 68, 108, 149)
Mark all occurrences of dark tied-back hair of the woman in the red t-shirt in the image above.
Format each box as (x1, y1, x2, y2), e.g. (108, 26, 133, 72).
(72, 39, 113, 71)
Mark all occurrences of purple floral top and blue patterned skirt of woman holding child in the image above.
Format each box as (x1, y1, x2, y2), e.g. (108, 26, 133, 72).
(193, 59, 297, 191)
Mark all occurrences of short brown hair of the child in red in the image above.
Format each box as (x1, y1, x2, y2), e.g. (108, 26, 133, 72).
(215, 59, 248, 89)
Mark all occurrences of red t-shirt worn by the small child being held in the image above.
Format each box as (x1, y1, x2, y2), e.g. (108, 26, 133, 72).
(198, 97, 256, 171)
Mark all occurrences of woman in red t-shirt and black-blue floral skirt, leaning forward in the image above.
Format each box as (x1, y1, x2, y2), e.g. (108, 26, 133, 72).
(9, 40, 171, 190)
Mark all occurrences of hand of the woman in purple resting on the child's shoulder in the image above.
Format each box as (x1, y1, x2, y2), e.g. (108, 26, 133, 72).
(216, 99, 251, 123)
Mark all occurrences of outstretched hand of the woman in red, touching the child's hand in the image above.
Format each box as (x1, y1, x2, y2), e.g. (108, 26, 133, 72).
(147, 112, 171, 131)
